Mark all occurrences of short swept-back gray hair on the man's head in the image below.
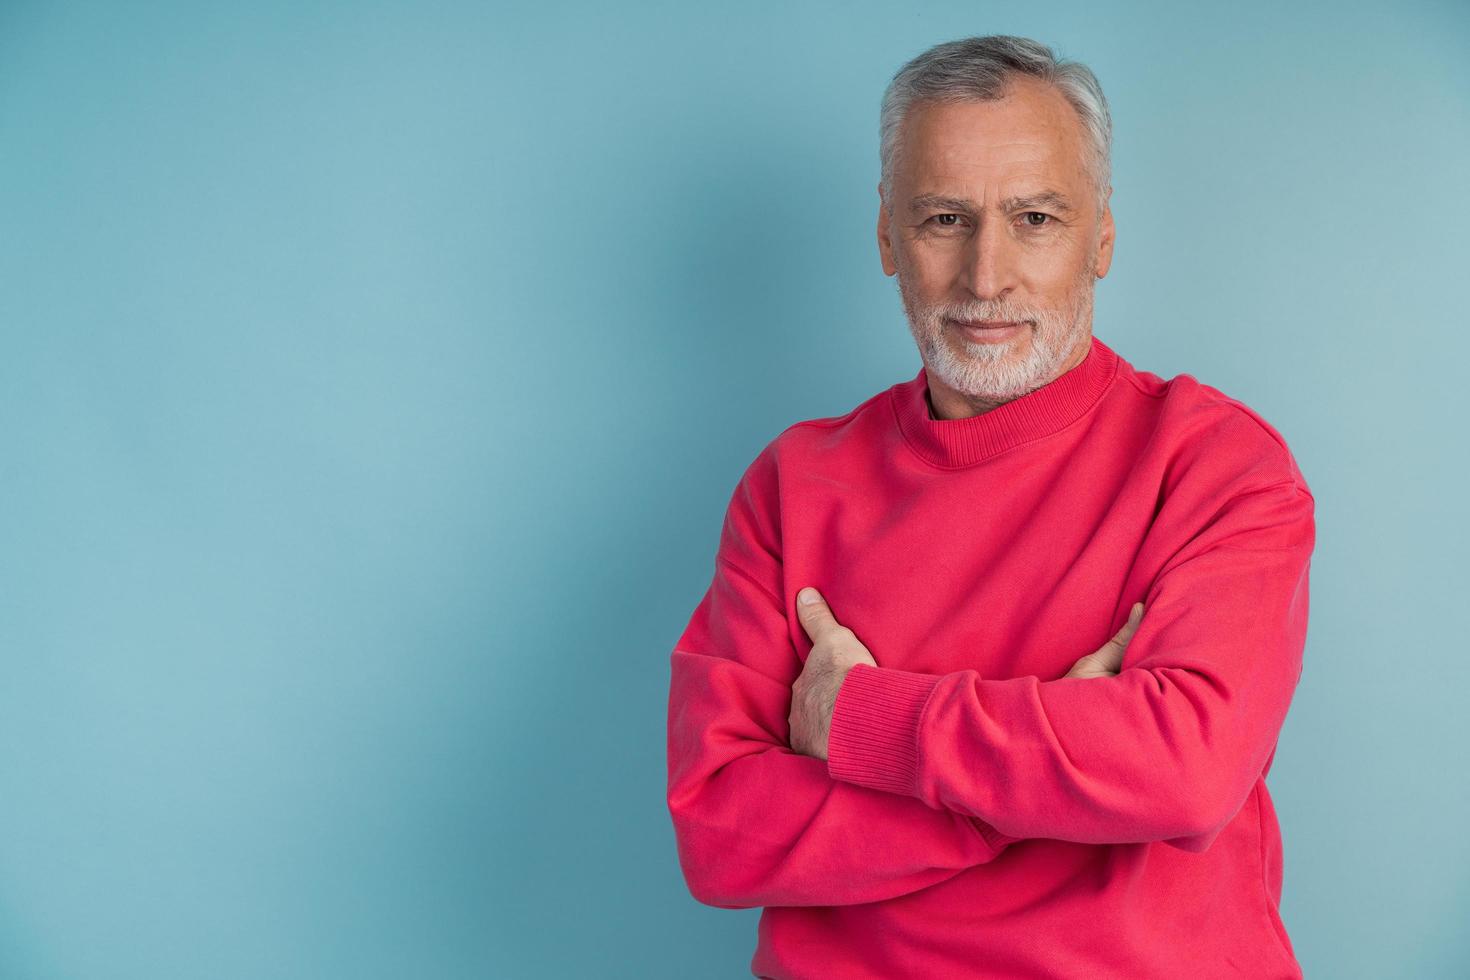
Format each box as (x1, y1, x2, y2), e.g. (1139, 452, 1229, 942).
(878, 34, 1113, 212)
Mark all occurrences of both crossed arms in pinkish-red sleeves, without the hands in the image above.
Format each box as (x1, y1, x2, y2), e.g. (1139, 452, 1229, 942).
(667, 454, 1314, 908)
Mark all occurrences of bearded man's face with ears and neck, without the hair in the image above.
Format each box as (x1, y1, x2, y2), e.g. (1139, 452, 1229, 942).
(878, 78, 1113, 419)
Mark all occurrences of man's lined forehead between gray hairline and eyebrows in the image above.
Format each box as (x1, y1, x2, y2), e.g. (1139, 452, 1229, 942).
(894, 78, 1086, 197)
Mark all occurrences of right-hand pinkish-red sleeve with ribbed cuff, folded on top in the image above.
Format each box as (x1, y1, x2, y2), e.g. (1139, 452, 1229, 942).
(828, 480, 1316, 851)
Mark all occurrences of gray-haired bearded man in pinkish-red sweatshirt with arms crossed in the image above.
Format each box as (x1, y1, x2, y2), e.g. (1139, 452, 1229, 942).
(667, 37, 1316, 980)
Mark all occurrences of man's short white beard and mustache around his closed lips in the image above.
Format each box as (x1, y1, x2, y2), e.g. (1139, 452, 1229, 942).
(898, 262, 1097, 403)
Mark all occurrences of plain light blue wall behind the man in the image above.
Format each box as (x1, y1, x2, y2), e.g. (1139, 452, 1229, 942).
(0, 1, 1470, 980)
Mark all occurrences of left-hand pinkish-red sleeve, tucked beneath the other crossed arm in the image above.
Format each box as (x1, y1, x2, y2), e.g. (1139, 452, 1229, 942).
(667, 444, 1013, 908)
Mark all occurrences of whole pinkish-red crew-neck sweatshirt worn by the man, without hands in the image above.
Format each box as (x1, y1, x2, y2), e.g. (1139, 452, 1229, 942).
(667, 338, 1314, 980)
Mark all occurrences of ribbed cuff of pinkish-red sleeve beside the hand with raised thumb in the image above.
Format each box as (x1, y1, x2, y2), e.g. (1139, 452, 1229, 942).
(828, 664, 941, 796)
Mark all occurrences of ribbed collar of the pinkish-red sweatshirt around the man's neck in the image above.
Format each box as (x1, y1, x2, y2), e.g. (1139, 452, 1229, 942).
(889, 336, 1119, 467)
